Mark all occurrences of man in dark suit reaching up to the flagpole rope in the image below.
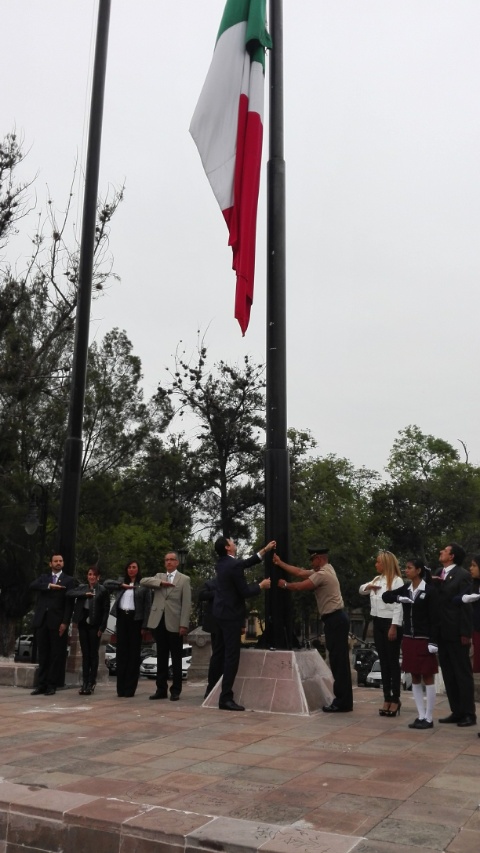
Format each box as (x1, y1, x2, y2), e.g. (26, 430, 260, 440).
(208, 536, 276, 711)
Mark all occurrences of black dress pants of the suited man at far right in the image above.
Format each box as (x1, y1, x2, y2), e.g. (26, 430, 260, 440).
(438, 640, 475, 717)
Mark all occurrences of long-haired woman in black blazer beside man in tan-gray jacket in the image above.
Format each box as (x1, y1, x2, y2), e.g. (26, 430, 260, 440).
(105, 560, 151, 697)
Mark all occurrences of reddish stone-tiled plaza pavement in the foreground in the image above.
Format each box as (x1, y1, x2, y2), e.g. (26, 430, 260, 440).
(0, 680, 480, 853)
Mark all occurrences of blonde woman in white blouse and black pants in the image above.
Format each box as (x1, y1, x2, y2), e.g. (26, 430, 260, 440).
(359, 551, 403, 717)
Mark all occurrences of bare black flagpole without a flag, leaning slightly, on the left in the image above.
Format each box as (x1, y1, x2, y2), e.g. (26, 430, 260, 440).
(57, 0, 111, 574)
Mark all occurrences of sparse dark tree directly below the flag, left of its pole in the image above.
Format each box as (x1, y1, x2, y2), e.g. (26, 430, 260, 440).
(156, 344, 265, 539)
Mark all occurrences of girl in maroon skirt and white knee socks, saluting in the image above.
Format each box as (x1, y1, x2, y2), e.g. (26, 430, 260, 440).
(382, 559, 438, 729)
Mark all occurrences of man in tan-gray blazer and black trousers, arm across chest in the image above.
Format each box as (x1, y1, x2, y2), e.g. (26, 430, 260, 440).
(140, 551, 192, 702)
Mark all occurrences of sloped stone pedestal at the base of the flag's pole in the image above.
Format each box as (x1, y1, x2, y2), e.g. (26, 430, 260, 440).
(203, 649, 334, 716)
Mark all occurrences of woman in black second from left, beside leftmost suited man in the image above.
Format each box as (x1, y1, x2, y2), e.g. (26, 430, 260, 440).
(67, 566, 110, 696)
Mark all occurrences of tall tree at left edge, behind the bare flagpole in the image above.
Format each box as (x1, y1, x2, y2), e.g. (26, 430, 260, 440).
(0, 134, 122, 654)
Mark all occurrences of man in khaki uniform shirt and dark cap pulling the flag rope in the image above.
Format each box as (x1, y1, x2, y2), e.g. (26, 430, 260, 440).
(273, 548, 353, 713)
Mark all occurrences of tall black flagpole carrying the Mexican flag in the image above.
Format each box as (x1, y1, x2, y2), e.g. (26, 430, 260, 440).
(265, 0, 292, 649)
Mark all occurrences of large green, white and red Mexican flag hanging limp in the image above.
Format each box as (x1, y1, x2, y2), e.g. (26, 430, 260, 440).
(190, 0, 272, 334)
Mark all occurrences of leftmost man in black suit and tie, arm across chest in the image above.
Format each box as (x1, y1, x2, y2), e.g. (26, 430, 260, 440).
(30, 554, 75, 696)
